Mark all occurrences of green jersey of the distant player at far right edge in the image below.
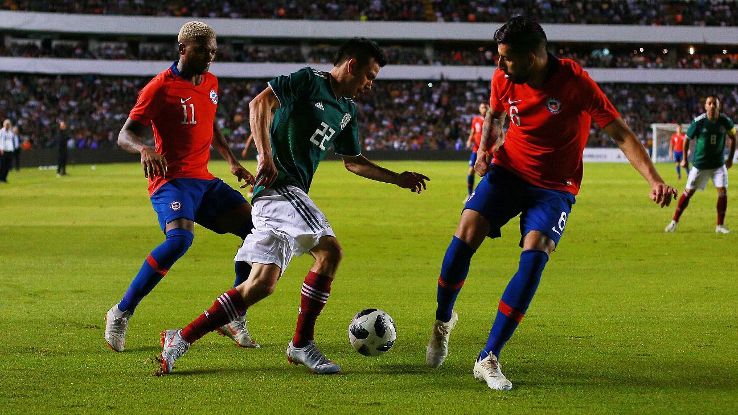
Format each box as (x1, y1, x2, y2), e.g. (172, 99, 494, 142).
(687, 114, 735, 170)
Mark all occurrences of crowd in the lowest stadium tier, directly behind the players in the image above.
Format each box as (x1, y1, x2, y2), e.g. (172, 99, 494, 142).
(0, 75, 738, 151)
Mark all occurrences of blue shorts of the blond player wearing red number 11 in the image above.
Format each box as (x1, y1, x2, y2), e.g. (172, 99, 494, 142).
(151, 178, 247, 233)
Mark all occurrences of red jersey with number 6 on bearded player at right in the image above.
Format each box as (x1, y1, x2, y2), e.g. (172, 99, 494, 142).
(489, 55, 620, 195)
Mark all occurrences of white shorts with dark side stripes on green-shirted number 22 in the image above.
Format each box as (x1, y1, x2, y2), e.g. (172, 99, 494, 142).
(236, 186, 336, 274)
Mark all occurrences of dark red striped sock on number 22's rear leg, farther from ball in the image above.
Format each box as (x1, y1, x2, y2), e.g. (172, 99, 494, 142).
(182, 288, 246, 343)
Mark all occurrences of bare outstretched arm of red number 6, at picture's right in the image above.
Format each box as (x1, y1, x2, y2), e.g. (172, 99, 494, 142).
(604, 118, 677, 207)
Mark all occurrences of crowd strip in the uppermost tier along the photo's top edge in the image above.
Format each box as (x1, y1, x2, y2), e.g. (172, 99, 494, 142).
(0, 0, 738, 26)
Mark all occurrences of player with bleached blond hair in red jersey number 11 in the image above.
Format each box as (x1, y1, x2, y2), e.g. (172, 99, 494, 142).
(105, 21, 258, 352)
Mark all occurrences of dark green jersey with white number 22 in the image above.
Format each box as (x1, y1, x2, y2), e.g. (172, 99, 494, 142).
(254, 67, 361, 199)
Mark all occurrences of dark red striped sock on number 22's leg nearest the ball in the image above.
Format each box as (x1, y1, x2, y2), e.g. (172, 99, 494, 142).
(292, 271, 333, 347)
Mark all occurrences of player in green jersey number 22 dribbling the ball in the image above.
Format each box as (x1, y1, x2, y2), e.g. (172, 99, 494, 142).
(160, 38, 429, 374)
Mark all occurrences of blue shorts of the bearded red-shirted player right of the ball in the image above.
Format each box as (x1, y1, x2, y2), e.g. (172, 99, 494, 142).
(464, 165, 576, 246)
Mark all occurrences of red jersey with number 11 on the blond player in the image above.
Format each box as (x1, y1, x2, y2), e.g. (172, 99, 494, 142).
(128, 64, 218, 194)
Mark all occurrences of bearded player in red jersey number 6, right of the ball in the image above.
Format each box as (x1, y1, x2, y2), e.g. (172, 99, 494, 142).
(426, 16, 676, 390)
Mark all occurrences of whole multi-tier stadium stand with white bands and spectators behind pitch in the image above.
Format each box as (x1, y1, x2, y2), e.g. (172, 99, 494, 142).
(0, 7, 738, 162)
